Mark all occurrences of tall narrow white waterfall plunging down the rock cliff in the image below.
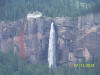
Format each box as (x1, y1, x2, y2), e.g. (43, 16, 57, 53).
(48, 22, 56, 68)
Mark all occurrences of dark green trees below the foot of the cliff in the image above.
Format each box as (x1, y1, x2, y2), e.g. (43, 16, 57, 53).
(0, 52, 100, 75)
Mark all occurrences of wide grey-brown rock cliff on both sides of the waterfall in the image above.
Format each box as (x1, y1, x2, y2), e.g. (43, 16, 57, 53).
(0, 14, 100, 64)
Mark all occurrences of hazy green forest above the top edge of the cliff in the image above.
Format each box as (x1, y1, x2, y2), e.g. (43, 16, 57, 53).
(0, 0, 100, 20)
